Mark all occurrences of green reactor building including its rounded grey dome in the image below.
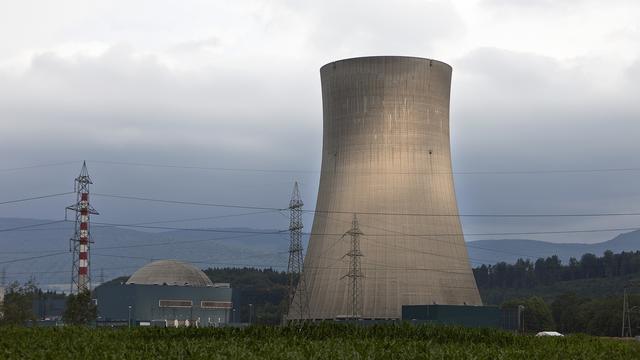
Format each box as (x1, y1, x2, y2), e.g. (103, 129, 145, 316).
(94, 260, 234, 327)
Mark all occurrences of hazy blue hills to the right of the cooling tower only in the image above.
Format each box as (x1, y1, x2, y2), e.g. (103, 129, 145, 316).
(467, 230, 640, 266)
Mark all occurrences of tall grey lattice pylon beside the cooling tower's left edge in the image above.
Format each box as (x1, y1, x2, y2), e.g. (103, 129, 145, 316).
(287, 181, 309, 320)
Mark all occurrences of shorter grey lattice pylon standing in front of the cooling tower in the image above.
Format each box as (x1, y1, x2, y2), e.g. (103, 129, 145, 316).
(342, 214, 364, 319)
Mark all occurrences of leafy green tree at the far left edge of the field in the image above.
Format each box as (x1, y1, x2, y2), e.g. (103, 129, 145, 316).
(0, 280, 38, 325)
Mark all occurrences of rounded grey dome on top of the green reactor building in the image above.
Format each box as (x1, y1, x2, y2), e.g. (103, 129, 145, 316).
(127, 260, 213, 287)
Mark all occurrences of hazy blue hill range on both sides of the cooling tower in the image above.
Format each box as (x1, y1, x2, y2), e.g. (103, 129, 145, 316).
(0, 218, 640, 290)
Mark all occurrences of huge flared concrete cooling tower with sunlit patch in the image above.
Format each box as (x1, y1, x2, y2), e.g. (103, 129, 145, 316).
(289, 56, 481, 319)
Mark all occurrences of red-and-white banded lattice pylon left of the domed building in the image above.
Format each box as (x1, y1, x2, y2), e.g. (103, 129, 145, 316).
(65, 162, 98, 294)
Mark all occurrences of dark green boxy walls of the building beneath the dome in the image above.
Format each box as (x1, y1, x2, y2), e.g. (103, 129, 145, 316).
(94, 284, 233, 326)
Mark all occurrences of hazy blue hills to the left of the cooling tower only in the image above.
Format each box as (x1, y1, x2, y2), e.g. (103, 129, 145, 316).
(0, 218, 288, 290)
